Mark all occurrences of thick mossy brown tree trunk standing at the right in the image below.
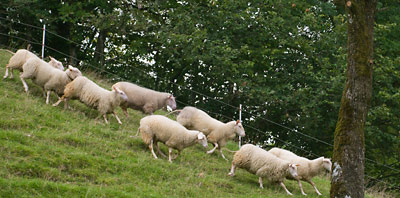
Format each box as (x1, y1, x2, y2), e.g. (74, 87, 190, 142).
(330, 0, 377, 198)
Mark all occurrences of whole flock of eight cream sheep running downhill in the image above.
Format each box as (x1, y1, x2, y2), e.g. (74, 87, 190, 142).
(4, 49, 332, 195)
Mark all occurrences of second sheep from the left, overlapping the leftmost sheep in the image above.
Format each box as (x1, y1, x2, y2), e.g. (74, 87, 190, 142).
(20, 58, 82, 104)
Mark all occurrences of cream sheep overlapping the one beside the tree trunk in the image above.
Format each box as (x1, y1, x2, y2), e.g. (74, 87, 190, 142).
(228, 144, 298, 195)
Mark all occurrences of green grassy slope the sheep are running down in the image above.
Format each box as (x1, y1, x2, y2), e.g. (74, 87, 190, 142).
(0, 50, 330, 198)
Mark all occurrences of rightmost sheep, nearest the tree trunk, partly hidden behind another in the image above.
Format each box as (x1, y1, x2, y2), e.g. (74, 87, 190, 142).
(268, 147, 332, 195)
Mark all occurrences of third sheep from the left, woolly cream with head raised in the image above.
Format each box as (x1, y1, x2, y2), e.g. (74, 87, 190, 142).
(53, 76, 128, 124)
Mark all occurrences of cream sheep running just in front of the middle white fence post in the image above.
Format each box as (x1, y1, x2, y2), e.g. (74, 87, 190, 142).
(176, 106, 246, 160)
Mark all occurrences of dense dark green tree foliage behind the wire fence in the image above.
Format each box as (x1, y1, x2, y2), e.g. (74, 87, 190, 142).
(0, 0, 400, 193)
